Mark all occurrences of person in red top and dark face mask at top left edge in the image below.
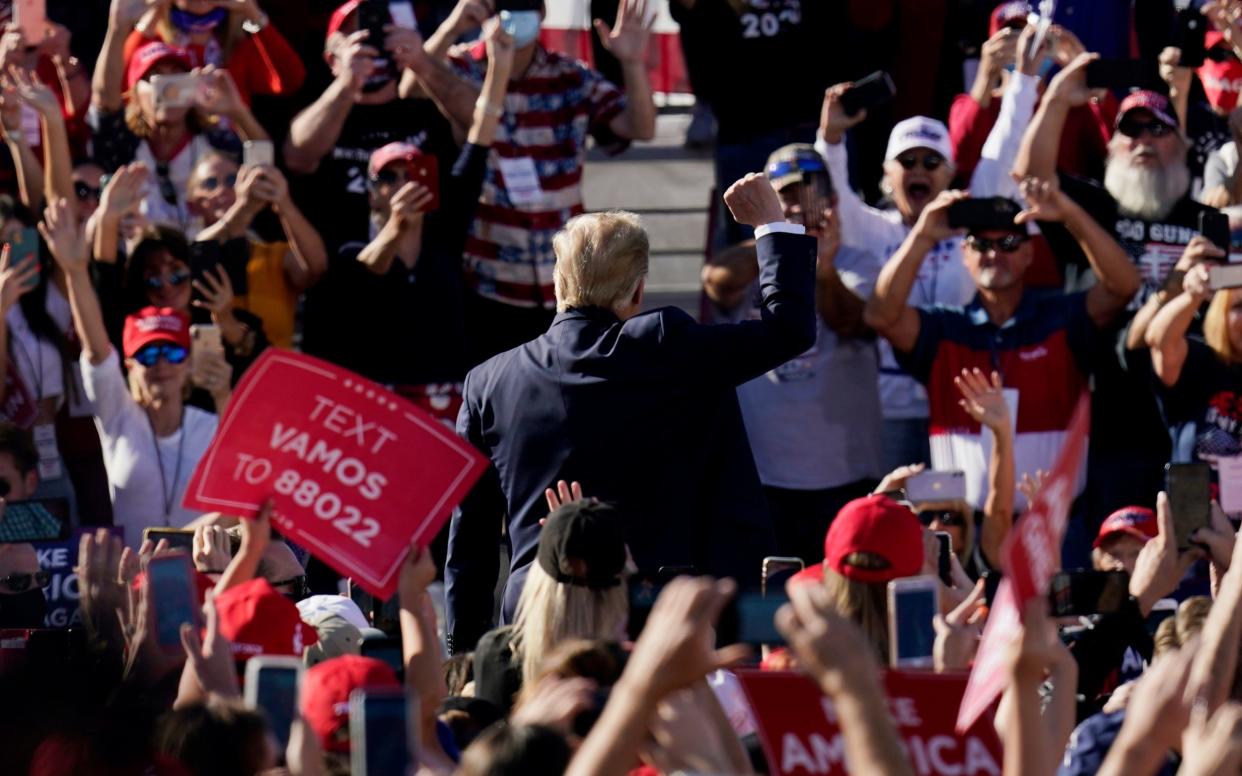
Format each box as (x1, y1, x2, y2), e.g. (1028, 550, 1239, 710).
(124, 0, 307, 104)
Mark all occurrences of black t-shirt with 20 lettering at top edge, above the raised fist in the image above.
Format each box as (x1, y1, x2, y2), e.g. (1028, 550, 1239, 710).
(669, 0, 846, 143)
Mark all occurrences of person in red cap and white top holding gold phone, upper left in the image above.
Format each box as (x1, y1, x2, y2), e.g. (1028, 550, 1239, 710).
(91, 0, 267, 237)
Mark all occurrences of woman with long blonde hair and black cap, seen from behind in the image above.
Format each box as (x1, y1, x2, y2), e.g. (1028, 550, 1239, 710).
(474, 499, 635, 711)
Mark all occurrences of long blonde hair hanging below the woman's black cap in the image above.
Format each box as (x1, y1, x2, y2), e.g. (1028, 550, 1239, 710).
(510, 562, 630, 685)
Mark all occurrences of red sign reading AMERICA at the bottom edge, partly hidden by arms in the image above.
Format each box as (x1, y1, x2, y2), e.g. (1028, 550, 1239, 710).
(738, 670, 1002, 776)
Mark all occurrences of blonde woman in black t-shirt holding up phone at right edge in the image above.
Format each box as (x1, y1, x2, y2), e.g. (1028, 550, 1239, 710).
(1146, 264, 1242, 467)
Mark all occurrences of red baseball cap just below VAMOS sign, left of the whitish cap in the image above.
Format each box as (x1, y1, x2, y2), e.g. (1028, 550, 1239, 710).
(216, 577, 319, 661)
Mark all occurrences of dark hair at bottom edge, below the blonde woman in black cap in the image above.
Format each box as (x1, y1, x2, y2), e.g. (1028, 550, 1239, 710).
(456, 723, 570, 776)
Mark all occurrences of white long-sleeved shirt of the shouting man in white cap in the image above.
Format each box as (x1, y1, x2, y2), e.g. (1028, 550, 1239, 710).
(815, 135, 975, 420)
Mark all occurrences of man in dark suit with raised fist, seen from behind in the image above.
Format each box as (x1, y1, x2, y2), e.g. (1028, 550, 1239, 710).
(445, 174, 816, 652)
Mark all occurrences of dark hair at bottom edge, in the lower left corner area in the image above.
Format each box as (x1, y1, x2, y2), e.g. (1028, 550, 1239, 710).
(155, 700, 267, 776)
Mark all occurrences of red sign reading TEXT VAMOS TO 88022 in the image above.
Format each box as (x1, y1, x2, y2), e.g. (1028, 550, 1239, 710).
(185, 348, 487, 598)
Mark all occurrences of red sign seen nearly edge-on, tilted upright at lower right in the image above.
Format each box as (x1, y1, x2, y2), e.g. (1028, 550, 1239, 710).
(958, 394, 1090, 730)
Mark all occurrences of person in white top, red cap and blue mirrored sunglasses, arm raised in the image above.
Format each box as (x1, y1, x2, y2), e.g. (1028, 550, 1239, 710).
(39, 200, 229, 548)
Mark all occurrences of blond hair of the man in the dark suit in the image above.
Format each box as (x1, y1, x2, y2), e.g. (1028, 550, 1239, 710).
(551, 210, 651, 312)
